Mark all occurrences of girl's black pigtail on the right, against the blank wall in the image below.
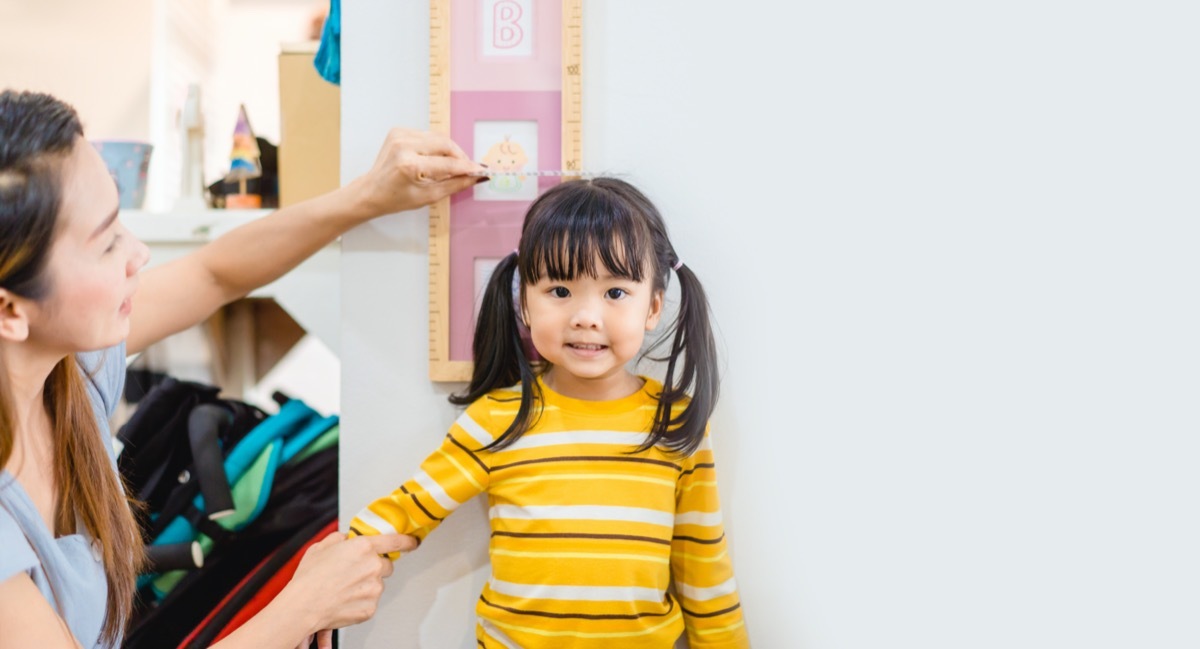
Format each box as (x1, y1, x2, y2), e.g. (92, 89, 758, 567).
(641, 259, 720, 456)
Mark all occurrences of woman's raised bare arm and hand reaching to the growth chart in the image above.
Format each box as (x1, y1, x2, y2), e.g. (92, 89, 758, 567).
(127, 130, 481, 354)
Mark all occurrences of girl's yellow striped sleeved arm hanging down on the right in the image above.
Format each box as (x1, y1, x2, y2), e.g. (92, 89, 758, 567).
(671, 432, 750, 649)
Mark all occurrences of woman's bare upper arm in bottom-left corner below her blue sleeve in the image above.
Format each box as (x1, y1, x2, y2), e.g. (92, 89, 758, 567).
(0, 572, 79, 649)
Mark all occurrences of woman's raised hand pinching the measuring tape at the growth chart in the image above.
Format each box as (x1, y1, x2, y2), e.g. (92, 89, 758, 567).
(348, 128, 484, 216)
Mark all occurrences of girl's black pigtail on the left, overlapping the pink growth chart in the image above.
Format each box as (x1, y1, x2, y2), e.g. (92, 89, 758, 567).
(450, 252, 536, 451)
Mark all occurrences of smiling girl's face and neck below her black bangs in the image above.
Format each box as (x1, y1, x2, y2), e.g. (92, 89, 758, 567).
(522, 260, 662, 401)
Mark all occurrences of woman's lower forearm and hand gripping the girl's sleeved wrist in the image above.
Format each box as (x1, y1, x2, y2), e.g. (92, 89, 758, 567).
(211, 533, 416, 649)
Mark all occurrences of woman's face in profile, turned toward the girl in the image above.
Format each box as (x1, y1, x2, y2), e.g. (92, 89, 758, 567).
(29, 138, 150, 354)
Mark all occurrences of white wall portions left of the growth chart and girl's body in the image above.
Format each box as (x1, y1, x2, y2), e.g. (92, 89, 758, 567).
(340, 0, 487, 649)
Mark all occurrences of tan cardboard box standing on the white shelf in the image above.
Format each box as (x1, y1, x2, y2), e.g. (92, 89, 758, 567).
(280, 41, 342, 208)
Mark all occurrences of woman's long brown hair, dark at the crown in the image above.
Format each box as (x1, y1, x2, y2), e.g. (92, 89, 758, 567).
(0, 90, 143, 644)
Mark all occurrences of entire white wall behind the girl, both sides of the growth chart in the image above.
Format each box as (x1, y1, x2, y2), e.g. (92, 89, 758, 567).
(342, 0, 1200, 649)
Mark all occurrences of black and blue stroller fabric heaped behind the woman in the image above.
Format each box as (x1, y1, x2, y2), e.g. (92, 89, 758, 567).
(118, 379, 337, 649)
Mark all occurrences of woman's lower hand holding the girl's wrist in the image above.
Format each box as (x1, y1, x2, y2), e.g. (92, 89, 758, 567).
(280, 531, 418, 648)
